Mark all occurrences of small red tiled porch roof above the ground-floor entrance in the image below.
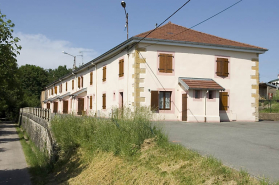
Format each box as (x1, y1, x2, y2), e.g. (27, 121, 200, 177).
(181, 79, 224, 90)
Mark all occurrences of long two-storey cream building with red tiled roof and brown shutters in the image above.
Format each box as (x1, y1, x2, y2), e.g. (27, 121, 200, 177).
(44, 22, 267, 122)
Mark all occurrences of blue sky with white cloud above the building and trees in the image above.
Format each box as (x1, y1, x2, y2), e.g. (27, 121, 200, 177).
(0, 0, 279, 82)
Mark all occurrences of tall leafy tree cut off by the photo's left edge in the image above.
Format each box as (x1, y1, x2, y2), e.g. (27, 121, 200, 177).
(0, 11, 22, 117)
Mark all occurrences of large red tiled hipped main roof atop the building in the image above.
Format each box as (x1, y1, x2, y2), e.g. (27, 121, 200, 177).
(135, 22, 267, 50)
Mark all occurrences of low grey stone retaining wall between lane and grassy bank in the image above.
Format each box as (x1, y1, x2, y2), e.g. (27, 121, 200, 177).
(19, 112, 56, 160)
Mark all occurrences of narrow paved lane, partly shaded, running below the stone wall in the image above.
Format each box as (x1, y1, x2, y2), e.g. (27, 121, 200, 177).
(0, 122, 31, 185)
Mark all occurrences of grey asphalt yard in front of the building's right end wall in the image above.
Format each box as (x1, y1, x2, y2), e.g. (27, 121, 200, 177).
(158, 121, 279, 182)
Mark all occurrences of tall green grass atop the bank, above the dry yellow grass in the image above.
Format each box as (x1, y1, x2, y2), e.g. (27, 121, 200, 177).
(51, 107, 162, 159)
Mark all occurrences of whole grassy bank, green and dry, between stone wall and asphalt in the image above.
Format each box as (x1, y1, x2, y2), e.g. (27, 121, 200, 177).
(18, 108, 279, 185)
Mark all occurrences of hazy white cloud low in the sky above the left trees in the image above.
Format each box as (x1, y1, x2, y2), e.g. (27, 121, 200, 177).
(15, 32, 97, 69)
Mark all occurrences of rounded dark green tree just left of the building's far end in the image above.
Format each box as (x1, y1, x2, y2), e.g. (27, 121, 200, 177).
(19, 64, 48, 107)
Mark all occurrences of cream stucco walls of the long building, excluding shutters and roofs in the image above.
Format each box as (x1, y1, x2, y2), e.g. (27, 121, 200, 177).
(44, 25, 265, 122)
